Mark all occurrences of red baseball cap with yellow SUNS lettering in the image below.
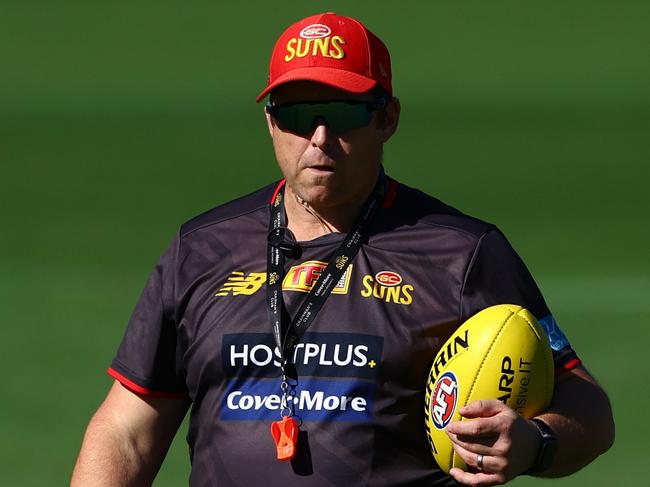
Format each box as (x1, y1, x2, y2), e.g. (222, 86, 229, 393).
(256, 12, 393, 102)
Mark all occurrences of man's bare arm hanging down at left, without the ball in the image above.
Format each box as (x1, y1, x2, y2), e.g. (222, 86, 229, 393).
(70, 381, 189, 487)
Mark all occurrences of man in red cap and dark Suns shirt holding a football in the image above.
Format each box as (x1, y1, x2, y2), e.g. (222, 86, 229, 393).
(72, 13, 613, 486)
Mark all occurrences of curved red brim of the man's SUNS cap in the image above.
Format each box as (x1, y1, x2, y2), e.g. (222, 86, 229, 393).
(255, 66, 377, 102)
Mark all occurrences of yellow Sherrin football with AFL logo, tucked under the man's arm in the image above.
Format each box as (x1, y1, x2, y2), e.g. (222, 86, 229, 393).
(425, 304, 555, 473)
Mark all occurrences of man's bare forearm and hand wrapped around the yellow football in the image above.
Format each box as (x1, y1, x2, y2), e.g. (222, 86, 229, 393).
(447, 367, 614, 485)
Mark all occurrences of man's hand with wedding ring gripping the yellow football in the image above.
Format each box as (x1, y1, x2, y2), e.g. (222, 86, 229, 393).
(447, 400, 541, 486)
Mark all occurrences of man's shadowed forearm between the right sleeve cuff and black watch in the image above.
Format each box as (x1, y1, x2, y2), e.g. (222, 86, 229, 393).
(539, 369, 614, 477)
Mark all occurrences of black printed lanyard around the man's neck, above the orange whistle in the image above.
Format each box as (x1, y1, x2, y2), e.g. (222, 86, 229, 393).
(266, 170, 386, 381)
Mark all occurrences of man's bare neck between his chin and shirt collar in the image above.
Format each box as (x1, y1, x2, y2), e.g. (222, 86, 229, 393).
(284, 186, 366, 242)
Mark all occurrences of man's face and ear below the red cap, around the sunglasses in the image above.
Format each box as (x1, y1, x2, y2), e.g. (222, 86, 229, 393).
(267, 81, 399, 213)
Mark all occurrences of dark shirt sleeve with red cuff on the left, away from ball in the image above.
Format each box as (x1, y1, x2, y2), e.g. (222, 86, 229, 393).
(108, 236, 187, 397)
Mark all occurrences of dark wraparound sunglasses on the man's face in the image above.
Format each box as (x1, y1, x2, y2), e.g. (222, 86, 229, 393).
(266, 98, 386, 136)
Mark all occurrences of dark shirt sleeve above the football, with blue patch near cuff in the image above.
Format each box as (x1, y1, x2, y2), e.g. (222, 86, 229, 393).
(460, 228, 580, 373)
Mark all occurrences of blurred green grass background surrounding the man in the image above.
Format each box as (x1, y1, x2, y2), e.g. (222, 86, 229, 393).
(0, 0, 650, 486)
